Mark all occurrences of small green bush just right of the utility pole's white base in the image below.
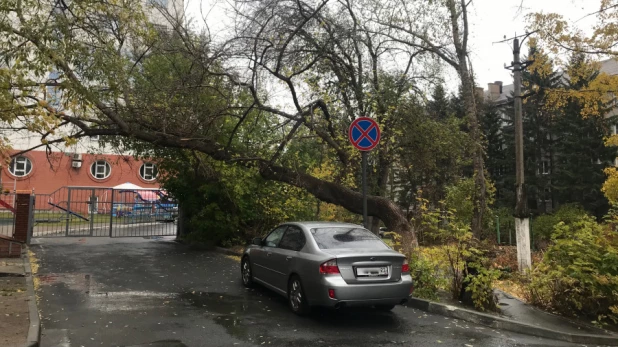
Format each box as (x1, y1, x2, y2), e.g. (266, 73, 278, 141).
(532, 204, 588, 248)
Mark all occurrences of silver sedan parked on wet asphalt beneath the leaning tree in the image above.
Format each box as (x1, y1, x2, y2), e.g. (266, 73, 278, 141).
(241, 222, 412, 315)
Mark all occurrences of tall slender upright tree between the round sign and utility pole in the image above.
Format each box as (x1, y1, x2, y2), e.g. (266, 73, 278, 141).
(371, 0, 487, 237)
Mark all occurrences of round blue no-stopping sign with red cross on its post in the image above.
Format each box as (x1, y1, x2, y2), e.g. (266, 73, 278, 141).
(348, 117, 380, 229)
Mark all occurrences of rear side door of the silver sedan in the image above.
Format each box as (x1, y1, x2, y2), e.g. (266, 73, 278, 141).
(269, 225, 305, 292)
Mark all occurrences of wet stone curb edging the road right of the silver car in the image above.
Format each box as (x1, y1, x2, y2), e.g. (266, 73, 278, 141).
(406, 297, 618, 346)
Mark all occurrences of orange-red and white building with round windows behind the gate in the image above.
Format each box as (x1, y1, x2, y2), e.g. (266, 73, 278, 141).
(0, 0, 184, 194)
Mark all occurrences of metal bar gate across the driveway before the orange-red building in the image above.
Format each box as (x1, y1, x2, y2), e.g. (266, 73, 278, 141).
(31, 187, 178, 237)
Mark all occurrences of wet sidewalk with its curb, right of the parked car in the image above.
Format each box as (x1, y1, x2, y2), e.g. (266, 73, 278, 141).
(407, 290, 618, 346)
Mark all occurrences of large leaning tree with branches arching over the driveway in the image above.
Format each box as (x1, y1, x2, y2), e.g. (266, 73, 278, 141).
(0, 0, 476, 244)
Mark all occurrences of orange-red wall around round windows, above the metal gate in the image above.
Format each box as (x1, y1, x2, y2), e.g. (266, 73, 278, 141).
(2, 151, 159, 194)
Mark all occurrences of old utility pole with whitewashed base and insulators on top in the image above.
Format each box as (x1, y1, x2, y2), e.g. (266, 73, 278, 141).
(506, 35, 532, 272)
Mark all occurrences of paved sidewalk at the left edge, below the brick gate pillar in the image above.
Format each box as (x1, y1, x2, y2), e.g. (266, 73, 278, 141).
(0, 258, 30, 347)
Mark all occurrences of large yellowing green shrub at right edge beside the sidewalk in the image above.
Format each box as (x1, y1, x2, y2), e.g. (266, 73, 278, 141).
(527, 216, 618, 323)
